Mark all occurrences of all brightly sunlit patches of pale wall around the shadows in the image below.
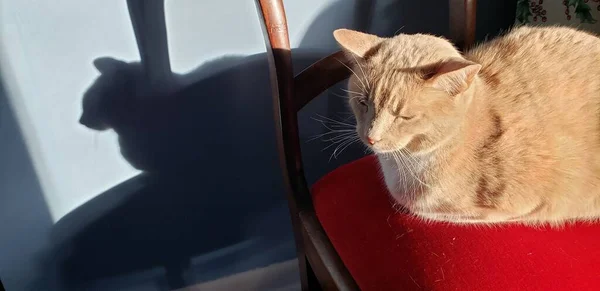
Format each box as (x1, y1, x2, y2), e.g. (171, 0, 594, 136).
(0, 0, 353, 221)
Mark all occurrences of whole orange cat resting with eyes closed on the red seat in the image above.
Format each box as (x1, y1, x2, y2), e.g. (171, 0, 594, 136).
(334, 26, 600, 225)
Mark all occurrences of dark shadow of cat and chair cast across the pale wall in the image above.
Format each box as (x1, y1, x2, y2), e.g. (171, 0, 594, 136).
(18, 1, 516, 290)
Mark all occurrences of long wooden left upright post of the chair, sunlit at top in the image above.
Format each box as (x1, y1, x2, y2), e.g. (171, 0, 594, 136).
(255, 0, 321, 291)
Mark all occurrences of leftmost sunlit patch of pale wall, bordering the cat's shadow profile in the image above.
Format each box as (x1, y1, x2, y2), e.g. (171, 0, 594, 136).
(0, 0, 142, 221)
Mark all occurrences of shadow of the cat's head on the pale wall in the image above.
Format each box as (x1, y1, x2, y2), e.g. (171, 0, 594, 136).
(79, 57, 144, 130)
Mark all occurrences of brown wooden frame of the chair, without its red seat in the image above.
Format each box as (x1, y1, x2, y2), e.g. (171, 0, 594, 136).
(255, 0, 477, 290)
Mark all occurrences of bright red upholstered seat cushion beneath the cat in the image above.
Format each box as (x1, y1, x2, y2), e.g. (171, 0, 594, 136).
(312, 156, 600, 291)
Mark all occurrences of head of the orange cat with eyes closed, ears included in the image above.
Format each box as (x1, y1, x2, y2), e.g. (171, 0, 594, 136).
(334, 29, 481, 154)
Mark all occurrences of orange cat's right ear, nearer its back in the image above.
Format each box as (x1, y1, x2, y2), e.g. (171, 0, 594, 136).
(427, 58, 481, 96)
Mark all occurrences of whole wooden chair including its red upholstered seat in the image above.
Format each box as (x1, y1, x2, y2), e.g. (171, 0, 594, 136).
(256, 0, 600, 291)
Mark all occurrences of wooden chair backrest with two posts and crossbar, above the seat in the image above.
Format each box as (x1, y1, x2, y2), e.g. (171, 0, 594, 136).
(255, 0, 476, 215)
